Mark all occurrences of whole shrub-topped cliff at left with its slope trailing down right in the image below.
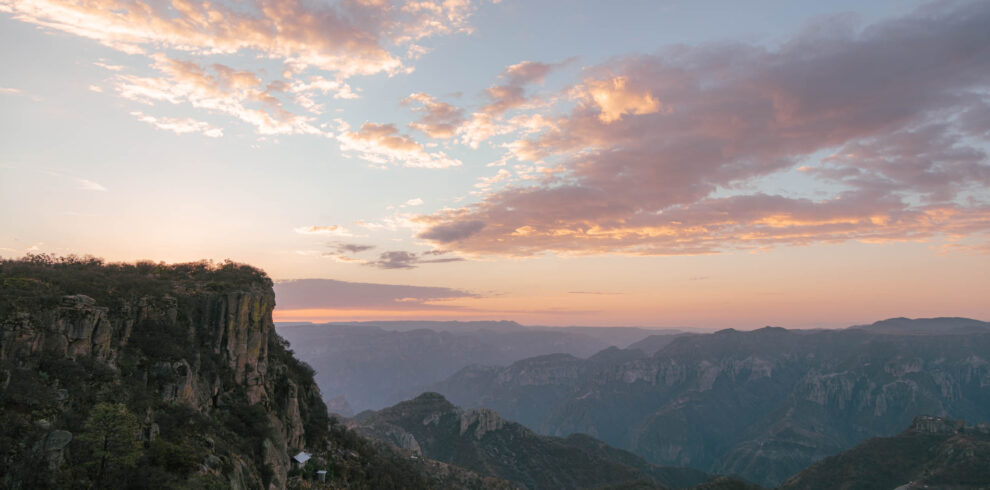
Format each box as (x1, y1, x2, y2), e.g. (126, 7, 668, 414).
(0, 256, 496, 489)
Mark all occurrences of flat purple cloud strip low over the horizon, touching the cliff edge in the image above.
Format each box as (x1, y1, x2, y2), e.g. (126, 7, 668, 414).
(275, 279, 478, 310)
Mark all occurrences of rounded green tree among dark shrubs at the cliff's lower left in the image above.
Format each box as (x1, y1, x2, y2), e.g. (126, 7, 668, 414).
(79, 403, 143, 488)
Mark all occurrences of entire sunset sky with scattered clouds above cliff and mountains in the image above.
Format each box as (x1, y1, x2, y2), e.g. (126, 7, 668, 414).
(0, 0, 990, 328)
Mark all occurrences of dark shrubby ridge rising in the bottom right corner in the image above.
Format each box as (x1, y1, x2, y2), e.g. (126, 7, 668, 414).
(780, 416, 990, 490)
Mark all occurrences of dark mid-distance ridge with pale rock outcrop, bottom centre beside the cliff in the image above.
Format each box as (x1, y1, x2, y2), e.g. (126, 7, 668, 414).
(353, 393, 706, 489)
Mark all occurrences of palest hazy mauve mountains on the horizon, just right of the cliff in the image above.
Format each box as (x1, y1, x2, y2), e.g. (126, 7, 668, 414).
(276, 322, 680, 415)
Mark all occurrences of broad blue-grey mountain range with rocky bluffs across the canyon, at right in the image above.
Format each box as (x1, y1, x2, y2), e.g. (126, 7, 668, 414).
(432, 327, 990, 486)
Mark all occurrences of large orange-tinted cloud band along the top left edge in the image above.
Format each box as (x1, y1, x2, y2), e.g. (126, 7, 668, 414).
(0, 0, 484, 77)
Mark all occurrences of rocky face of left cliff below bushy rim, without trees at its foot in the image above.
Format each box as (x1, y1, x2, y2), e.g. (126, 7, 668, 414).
(0, 262, 326, 488)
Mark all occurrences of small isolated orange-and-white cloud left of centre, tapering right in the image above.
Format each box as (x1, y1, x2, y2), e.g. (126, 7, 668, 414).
(337, 121, 461, 168)
